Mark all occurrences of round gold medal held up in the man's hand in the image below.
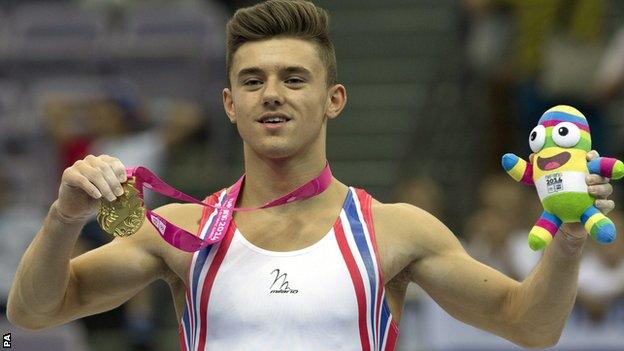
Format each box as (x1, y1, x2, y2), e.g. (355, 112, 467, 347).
(97, 178, 145, 236)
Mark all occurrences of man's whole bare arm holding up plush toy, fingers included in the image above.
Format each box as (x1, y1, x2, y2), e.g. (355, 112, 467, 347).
(385, 175, 614, 347)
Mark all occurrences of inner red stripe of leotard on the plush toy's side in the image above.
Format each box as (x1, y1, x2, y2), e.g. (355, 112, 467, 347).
(334, 217, 370, 351)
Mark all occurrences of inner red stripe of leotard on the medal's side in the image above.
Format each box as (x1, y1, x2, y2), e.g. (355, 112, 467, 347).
(198, 221, 235, 350)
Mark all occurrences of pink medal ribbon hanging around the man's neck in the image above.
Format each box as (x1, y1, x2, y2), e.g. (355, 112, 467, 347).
(126, 164, 332, 252)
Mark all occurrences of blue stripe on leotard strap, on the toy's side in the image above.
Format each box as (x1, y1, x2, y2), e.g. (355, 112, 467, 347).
(346, 189, 377, 350)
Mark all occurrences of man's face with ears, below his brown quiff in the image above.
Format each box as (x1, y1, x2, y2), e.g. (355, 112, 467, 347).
(223, 38, 346, 158)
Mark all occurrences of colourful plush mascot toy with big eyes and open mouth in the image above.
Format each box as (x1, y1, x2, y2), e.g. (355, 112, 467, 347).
(503, 105, 624, 250)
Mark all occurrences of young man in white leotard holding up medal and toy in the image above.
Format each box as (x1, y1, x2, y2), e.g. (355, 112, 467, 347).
(8, 0, 614, 350)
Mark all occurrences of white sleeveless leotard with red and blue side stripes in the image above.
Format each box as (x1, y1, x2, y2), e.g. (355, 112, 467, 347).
(179, 188, 399, 351)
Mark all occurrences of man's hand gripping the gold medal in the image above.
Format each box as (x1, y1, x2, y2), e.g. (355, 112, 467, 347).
(54, 155, 127, 223)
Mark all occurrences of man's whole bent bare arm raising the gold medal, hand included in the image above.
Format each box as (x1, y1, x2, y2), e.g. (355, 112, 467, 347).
(7, 156, 190, 330)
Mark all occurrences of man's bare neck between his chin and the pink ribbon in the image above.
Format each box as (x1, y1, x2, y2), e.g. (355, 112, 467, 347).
(237, 149, 327, 207)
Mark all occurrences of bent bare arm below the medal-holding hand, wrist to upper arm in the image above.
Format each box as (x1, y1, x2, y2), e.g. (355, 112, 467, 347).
(7, 205, 177, 330)
